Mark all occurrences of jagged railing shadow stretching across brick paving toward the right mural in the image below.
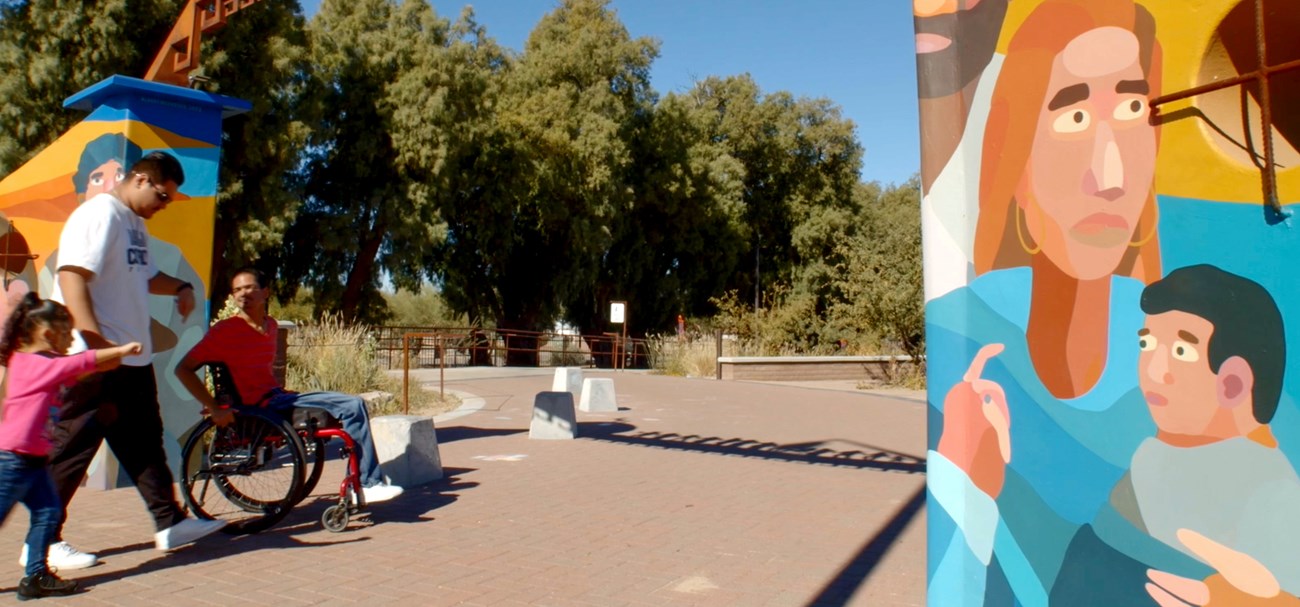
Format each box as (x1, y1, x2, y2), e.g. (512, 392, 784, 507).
(579, 422, 926, 474)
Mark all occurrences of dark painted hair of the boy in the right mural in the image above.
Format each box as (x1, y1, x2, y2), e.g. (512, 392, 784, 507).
(1141, 265, 1287, 424)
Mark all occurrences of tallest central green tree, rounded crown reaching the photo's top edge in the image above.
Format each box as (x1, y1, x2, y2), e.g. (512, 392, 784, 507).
(443, 0, 658, 364)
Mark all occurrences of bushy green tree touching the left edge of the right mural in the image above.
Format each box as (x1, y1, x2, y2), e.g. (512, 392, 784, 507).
(836, 175, 926, 359)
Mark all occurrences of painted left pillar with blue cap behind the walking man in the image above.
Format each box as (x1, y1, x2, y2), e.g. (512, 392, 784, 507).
(0, 77, 247, 487)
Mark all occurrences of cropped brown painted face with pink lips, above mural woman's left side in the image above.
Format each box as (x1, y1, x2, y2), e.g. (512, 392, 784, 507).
(911, 0, 1008, 99)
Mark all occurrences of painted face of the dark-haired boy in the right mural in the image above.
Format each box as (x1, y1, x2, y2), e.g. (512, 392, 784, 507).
(1138, 311, 1219, 437)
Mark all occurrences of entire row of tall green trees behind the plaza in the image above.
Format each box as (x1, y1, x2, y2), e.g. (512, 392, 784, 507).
(0, 0, 923, 352)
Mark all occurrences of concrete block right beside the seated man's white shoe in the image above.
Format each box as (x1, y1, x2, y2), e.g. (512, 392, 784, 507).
(371, 415, 442, 487)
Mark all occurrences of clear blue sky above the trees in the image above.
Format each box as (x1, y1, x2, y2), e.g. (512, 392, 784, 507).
(302, 0, 920, 183)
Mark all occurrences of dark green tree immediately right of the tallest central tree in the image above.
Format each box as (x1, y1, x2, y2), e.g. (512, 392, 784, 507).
(567, 88, 746, 343)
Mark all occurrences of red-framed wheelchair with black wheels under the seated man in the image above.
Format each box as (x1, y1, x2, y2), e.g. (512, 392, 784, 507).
(179, 363, 364, 534)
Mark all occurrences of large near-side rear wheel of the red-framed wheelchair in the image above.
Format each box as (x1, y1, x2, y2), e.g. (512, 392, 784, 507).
(181, 411, 306, 534)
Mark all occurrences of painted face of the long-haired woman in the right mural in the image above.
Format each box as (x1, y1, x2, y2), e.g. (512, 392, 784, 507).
(1017, 27, 1156, 279)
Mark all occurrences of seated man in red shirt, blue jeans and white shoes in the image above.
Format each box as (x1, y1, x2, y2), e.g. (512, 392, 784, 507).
(176, 268, 402, 503)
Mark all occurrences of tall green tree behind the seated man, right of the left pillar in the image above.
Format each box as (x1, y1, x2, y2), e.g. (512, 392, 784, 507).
(278, 0, 491, 321)
